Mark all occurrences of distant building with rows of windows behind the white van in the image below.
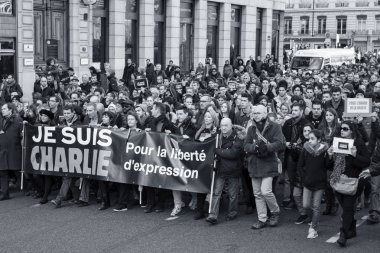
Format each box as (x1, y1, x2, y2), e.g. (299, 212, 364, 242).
(284, 0, 380, 53)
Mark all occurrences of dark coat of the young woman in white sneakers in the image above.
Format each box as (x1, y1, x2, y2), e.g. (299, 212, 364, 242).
(295, 142, 330, 191)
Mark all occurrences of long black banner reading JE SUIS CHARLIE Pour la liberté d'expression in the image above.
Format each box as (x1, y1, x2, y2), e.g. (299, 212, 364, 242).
(24, 125, 215, 193)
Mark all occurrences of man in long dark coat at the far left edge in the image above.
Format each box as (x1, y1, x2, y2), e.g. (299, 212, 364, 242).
(0, 103, 23, 201)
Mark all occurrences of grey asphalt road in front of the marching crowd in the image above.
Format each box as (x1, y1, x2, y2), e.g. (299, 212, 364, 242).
(0, 193, 380, 253)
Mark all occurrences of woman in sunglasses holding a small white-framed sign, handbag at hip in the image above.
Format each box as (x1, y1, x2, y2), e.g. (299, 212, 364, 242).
(328, 121, 371, 247)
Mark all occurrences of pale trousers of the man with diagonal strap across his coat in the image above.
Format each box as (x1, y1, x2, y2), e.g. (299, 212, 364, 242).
(252, 177, 280, 222)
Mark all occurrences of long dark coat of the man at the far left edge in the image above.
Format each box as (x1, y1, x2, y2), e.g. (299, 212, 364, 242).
(0, 114, 23, 171)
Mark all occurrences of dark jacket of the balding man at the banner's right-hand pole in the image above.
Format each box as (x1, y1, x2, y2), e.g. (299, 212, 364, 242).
(215, 132, 244, 178)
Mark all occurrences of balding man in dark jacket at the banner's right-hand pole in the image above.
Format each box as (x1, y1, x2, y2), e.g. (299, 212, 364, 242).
(206, 118, 245, 224)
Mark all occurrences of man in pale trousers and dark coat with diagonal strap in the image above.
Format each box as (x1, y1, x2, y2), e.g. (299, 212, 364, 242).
(244, 104, 285, 229)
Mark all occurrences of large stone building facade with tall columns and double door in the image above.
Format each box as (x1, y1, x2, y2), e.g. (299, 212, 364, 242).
(0, 0, 285, 102)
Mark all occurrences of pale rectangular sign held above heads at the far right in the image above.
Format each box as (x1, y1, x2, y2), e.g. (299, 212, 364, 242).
(343, 98, 372, 117)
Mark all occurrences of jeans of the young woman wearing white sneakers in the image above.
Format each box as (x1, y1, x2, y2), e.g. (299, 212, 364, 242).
(303, 187, 324, 229)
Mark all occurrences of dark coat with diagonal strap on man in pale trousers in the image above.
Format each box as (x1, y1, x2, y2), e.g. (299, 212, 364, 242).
(244, 119, 285, 178)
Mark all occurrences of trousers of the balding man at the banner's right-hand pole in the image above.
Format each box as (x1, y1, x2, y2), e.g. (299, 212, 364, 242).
(209, 176, 240, 219)
